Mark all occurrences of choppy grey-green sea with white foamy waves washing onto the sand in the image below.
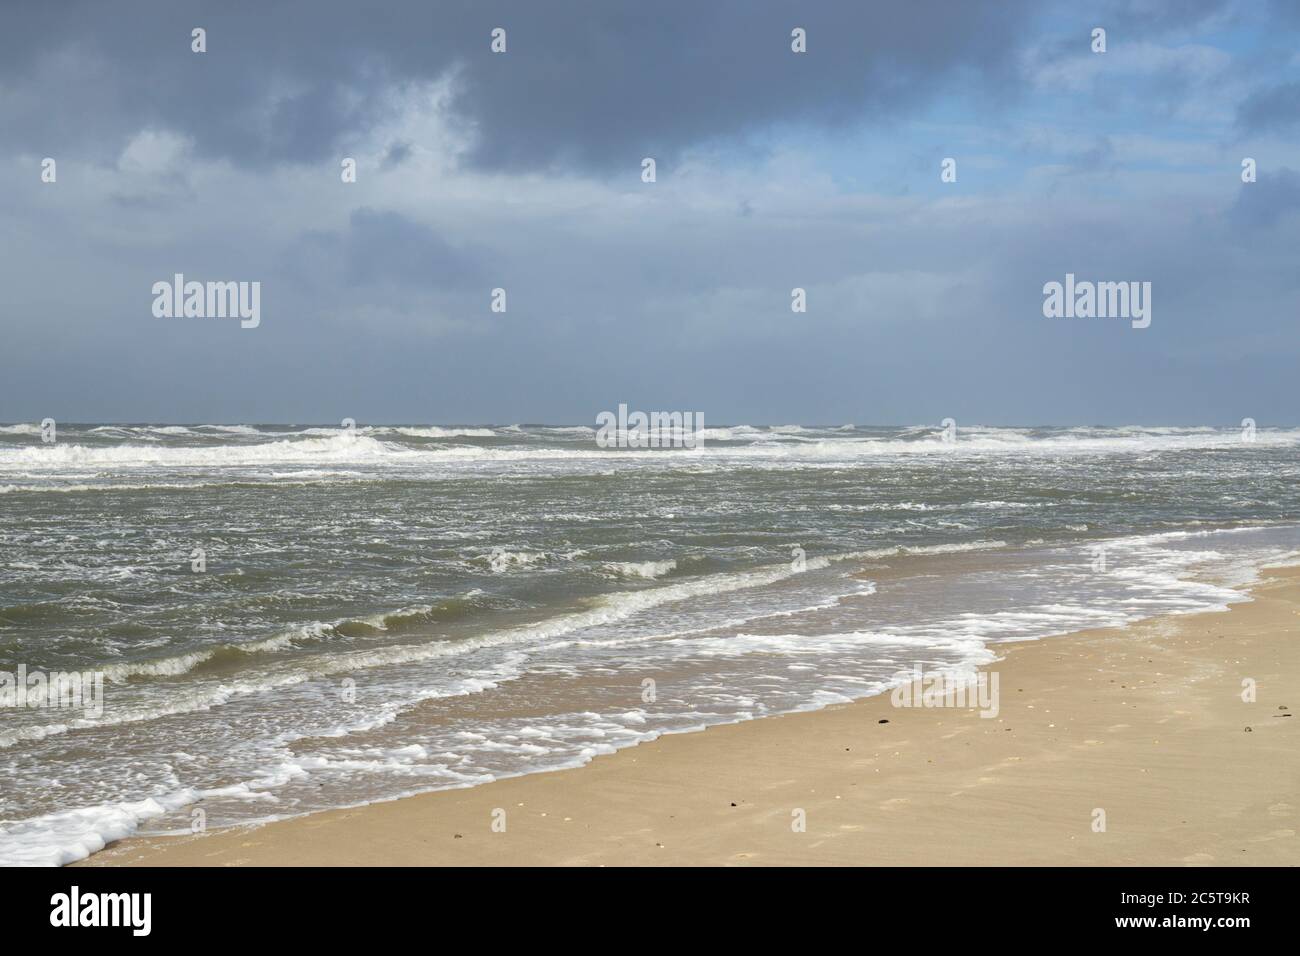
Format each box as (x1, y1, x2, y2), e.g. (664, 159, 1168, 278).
(0, 421, 1300, 865)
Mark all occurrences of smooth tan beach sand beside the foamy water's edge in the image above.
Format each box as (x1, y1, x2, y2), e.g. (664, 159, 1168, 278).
(82, 568, 1300, 866)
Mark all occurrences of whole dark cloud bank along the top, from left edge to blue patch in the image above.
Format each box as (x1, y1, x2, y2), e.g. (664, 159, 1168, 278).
(0, 0, 1034, 169)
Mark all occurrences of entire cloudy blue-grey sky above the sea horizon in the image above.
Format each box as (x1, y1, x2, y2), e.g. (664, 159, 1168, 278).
(0, 0, 1300, 427)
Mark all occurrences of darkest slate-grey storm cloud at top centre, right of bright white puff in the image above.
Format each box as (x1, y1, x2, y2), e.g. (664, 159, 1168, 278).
(447, 0, 1028, 168)
